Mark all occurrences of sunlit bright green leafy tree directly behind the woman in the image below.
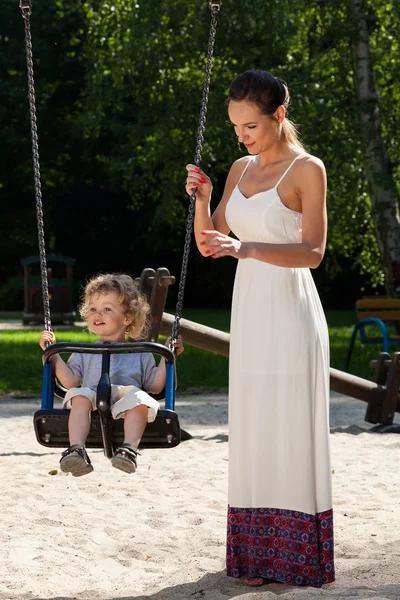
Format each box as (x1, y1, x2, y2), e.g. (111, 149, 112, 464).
(76, 0, 390, 298)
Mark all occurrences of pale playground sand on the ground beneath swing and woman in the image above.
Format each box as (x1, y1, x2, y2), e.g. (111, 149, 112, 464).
(0, 395, 400, 600)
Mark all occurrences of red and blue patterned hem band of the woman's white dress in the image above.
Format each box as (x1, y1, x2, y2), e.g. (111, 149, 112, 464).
(226, 506, 335, 587)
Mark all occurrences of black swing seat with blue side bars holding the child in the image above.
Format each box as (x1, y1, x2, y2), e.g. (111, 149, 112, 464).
(33, 342, 181, 458)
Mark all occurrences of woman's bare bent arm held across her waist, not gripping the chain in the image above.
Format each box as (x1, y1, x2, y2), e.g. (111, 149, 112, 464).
(201, 157, 327, 268)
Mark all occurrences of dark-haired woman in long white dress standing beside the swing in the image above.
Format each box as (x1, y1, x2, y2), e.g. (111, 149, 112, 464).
(186, 71, 335, 587)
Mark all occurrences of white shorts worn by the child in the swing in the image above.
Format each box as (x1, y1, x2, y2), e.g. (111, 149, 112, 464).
(62, 385, 160, 423)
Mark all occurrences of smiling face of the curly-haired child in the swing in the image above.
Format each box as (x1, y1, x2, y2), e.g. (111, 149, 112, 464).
(87, 292, 130, 342)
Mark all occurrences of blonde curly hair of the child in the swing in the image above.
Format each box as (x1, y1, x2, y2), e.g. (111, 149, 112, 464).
(78, 273, 150, 339)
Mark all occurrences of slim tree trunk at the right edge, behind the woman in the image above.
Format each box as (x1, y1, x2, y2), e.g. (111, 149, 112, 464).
(351, 0, 400, 297)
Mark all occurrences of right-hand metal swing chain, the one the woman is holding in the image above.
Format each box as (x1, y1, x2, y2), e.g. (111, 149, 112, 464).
(170, 0, 222, 348)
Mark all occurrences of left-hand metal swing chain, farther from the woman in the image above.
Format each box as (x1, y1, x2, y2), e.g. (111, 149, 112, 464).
(20, 0, 51, 331)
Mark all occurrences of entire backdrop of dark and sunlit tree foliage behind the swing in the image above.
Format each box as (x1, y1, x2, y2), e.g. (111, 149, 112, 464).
(0, 0, 400, 302)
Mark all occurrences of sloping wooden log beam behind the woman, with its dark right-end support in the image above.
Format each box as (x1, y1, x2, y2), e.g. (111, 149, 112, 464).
(160, 313, 400, 431)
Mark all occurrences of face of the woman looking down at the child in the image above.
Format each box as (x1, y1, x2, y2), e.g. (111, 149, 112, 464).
(228, 100, 285, 154)
